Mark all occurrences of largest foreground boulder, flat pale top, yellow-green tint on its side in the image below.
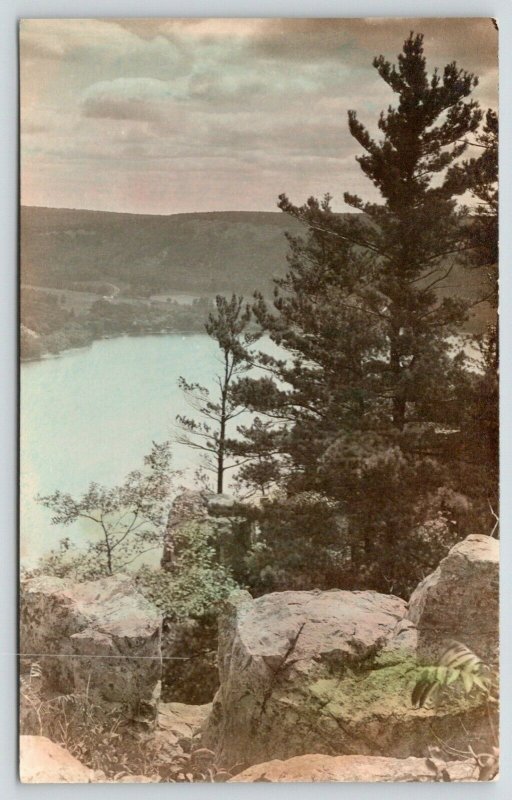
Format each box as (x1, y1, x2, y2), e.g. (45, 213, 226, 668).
(203, 590, 496, 769)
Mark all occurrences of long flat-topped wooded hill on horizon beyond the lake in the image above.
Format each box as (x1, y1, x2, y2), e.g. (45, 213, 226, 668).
(21, 206, 308, 294)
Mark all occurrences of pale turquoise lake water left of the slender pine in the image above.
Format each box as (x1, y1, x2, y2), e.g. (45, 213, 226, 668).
(20, 334, 244, 565)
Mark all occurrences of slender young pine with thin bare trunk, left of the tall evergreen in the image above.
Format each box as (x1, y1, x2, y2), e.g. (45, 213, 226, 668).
(176, 295, 254, 494)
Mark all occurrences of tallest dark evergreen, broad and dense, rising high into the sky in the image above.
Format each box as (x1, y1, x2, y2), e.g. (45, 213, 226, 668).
(236, 34, 481, 590)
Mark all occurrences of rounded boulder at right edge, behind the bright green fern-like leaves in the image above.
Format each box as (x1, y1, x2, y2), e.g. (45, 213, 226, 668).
(407, 535, 499, 664)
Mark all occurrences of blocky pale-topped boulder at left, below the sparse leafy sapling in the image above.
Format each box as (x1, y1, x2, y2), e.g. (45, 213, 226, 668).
(20, 575, 162, 722)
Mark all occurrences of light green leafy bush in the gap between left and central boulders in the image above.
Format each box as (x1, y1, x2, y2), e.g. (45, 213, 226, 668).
(136, 523, 237, 621)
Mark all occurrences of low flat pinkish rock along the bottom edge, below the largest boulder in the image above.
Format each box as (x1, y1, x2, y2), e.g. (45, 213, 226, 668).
(229, 754, 477, 783)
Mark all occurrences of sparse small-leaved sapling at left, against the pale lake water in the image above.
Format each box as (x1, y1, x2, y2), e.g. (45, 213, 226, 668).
(37, 442, 173, 578)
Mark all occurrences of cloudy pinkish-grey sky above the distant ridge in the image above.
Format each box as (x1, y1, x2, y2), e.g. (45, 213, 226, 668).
(20, 18, 498, 214)
